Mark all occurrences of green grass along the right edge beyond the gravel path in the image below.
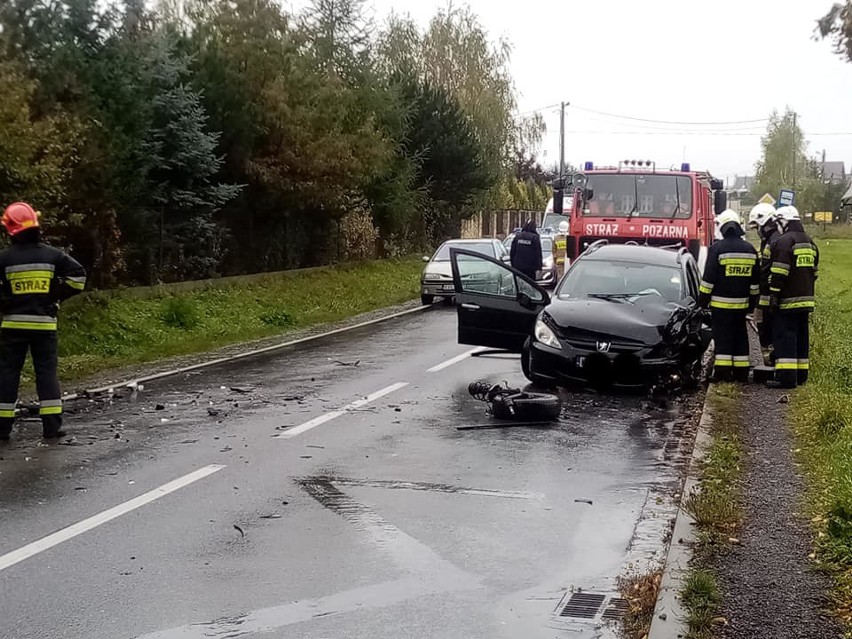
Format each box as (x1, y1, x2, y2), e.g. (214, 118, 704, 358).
(791, 236, 852, 629)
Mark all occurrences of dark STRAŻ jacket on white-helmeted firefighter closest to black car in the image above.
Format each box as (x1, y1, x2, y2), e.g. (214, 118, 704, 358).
(698, 237, 760, 311)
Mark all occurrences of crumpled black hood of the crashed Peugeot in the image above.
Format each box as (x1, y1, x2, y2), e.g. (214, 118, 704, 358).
(545, 298, 690, 346)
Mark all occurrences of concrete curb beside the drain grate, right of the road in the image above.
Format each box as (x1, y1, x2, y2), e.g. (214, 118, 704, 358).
(647, 390, 713, 639)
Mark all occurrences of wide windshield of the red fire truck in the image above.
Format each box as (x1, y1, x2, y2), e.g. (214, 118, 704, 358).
(583, 173, 692, 220)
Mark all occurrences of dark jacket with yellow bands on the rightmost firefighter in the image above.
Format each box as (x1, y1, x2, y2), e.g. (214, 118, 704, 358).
(769, 220, 819, 311)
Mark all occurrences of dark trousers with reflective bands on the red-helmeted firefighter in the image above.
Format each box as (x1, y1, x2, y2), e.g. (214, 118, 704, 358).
(0, 329, 62, 437)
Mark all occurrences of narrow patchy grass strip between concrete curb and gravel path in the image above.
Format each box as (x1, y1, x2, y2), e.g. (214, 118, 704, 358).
(681, 384, 743, 639)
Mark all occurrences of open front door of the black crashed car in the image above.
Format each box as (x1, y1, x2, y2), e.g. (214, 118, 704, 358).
(450, 248, 550, 353)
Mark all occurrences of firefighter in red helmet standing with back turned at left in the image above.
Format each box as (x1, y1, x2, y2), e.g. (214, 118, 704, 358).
(0, 202, 86, 440)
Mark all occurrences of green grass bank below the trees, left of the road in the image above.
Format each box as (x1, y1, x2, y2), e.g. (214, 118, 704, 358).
(43, 258, 423, 382)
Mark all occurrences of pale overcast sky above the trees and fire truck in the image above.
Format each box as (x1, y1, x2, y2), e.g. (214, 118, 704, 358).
(294, 0, 852, 185)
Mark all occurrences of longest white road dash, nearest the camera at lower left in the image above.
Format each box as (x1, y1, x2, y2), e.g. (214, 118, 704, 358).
(0, 464, 225, 570)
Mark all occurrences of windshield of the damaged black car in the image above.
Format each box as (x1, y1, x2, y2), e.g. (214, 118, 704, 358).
(557, 260, 684, 303)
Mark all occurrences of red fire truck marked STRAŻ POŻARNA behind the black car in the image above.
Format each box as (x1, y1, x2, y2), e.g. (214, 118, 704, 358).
(554, 160, 727, 267)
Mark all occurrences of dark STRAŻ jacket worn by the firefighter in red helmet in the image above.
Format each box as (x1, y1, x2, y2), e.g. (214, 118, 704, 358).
(0, 242, 86, 331)
